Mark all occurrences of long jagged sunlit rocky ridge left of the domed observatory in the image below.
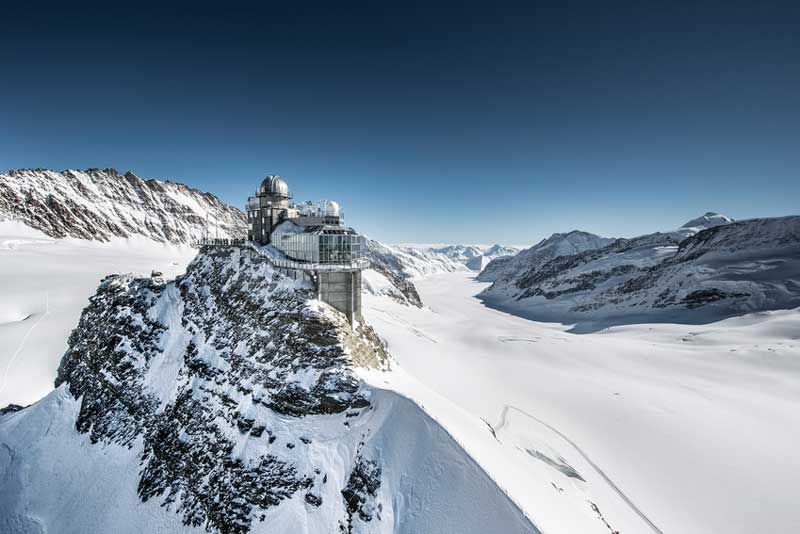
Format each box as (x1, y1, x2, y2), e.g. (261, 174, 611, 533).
(0, 169, 246, 244)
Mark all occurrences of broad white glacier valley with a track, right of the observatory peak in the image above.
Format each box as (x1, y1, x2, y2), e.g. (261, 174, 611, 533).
(364, 273, 800, 534)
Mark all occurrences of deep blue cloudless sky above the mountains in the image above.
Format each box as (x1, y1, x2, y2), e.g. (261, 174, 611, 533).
(0, 1, 800, 244)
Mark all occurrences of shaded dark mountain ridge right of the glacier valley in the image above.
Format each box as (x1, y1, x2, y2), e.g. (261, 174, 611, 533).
(481, 214, 800, 329)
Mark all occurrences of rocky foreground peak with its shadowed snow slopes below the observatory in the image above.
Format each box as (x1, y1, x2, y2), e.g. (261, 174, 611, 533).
(0, 248, 538, 534)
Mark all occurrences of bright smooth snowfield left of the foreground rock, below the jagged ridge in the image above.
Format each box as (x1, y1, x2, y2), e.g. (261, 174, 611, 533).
(0, 221, 197, 407)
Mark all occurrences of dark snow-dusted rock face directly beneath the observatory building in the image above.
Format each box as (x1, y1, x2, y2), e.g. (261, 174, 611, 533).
(56, 248, 386, 533)
